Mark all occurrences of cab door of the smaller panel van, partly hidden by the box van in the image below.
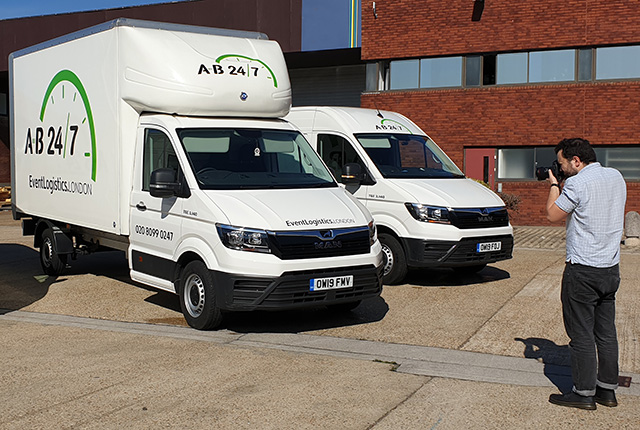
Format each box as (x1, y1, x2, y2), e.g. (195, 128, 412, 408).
(316, 133, 373, 203)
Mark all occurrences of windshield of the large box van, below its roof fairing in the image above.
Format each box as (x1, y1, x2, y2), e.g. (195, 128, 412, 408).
(177, 128, 338, 190)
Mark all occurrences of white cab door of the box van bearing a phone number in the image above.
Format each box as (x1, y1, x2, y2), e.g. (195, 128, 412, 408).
(129, 127, 183, 291)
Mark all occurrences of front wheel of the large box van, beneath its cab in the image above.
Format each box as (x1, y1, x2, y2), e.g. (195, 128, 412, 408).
(178, 261, 222, 330)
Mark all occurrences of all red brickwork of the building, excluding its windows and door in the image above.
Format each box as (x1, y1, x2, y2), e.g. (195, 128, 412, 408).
(361, 0, 640, 225)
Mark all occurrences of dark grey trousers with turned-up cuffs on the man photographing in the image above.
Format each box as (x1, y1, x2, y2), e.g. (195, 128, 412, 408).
(561, 263, 620, 396)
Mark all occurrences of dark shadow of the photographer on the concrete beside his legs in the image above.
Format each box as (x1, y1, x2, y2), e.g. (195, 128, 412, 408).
(514, 337, 573, 393)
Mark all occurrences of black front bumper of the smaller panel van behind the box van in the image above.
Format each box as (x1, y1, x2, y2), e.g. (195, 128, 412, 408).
(402, 234, 513, 267)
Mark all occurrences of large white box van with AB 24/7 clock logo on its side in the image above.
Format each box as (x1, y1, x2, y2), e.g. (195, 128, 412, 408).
(9, 19, 382, 329)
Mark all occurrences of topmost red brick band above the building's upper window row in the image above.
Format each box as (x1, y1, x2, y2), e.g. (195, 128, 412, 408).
(362, 0, 640, 60)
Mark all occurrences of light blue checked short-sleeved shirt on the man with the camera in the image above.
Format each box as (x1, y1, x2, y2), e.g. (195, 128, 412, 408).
(555, 162, 627, 267)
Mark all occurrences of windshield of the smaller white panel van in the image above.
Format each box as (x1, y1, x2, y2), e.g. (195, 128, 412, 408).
(356, 133, 464, 178)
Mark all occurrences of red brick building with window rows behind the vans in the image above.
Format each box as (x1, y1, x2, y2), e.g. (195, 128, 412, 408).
(361, 0, 640, 225)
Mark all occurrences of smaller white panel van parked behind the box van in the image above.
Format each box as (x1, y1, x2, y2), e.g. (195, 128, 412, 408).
(285, 107, 513, 284)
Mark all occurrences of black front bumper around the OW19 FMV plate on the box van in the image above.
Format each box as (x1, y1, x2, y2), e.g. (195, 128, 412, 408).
(211, 265, 382, 311)
